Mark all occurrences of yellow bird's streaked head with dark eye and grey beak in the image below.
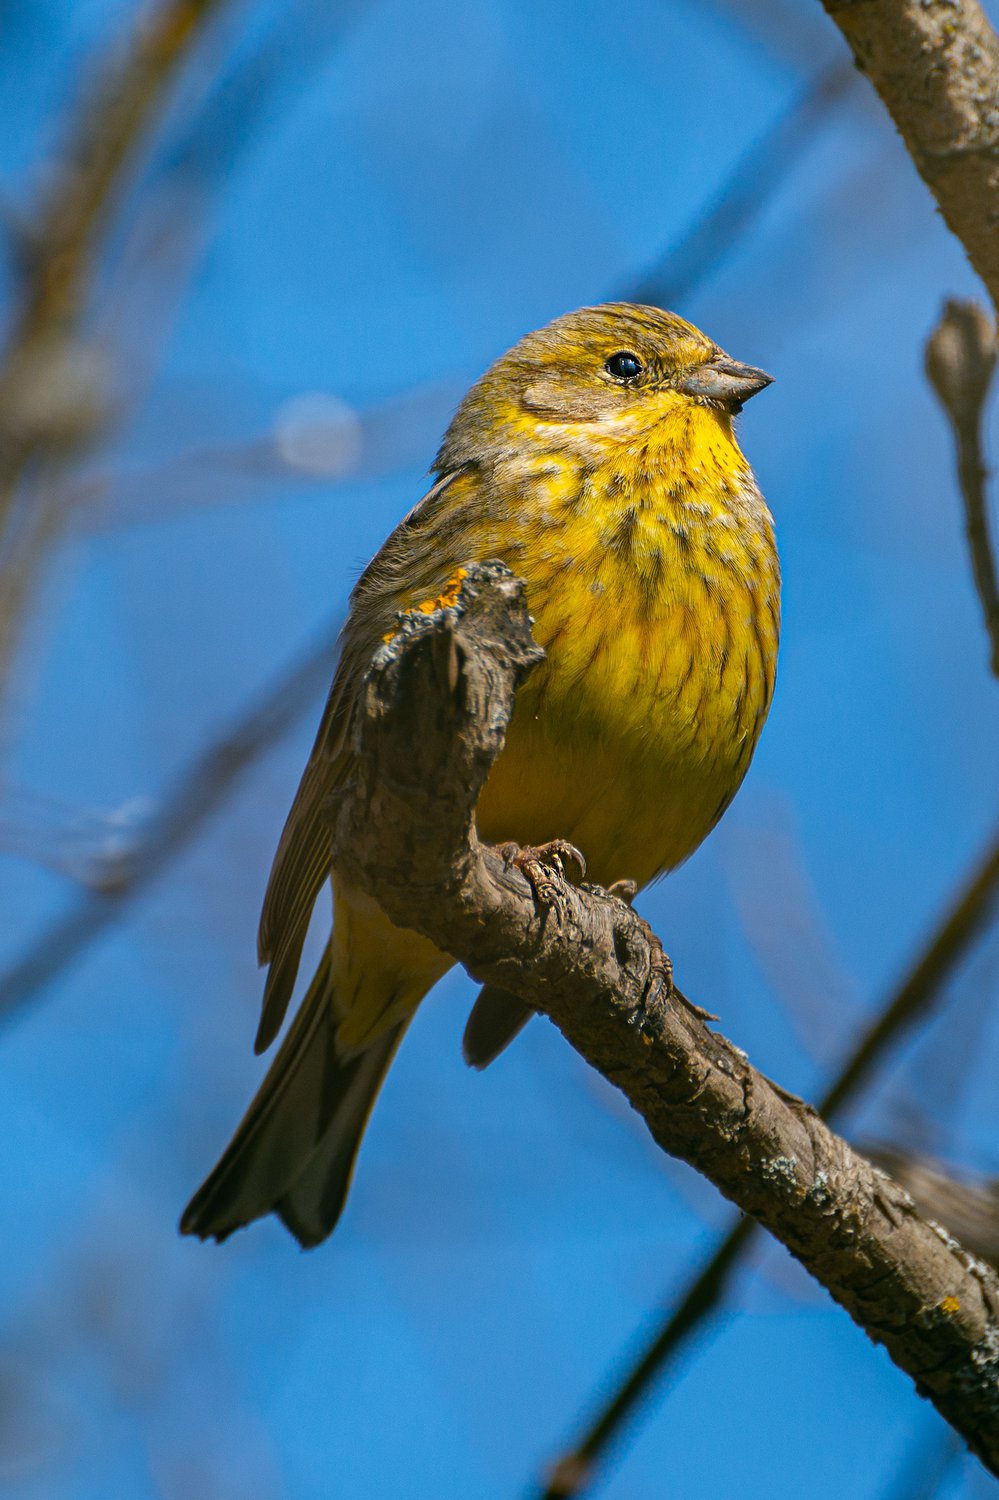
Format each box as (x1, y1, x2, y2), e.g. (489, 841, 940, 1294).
(435, 302, 773, 471)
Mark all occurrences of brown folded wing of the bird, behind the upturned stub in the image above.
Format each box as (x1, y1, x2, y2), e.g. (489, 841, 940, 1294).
(254, 471, 462, 1053)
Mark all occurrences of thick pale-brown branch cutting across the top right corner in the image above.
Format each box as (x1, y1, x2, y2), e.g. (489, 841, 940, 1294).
(822, 0, 999, 309)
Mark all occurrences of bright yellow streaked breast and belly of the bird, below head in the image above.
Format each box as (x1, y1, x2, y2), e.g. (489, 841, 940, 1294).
(477, 413, 780, 885)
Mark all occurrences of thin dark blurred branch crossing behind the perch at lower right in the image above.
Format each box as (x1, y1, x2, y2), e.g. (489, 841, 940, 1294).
(543, 828, 999, 1500)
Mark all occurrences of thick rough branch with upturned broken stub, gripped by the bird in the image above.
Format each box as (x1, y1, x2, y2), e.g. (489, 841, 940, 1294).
(329, 564, 999, 1472)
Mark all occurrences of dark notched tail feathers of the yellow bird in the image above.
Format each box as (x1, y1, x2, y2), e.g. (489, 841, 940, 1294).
(180, 947, 410, 1247)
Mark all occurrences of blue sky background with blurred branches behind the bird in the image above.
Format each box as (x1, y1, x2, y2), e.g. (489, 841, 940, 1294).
(0, 0, 999, 1500)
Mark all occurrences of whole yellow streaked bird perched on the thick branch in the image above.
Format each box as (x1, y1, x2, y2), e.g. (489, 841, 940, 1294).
(180, 303, 780, 1248)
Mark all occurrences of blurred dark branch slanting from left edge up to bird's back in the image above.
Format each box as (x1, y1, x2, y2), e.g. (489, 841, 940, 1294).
(0, 623, 339, 1023)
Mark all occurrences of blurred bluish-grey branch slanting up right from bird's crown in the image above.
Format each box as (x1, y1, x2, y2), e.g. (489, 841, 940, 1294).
(624, 59, 857, 308)
